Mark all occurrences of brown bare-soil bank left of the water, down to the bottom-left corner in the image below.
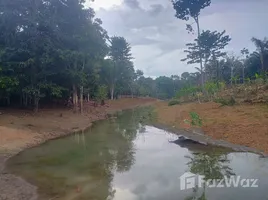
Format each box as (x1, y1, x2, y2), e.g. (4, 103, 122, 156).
(0, 98, 155, 200)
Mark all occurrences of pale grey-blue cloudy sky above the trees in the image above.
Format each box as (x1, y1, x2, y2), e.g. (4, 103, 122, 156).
(87, 0, 268, 77)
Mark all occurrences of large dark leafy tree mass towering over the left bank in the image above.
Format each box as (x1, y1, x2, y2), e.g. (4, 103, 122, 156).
(0, 0, 107, 111)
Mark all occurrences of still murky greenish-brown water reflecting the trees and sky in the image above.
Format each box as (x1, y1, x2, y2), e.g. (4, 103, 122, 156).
(7, 109, 268, 200)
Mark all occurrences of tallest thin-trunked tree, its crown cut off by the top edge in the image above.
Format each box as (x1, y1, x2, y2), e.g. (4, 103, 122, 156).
(172, 0, 211, 85)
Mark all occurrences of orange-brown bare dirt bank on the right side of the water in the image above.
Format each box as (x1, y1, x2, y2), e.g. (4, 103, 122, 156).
(155, 102, 268, 154)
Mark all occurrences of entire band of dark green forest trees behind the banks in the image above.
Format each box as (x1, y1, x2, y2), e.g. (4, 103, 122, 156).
(0, 0, 268, 111)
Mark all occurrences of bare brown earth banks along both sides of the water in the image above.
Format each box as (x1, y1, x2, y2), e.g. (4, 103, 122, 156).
(0, 99, 268, 200)
